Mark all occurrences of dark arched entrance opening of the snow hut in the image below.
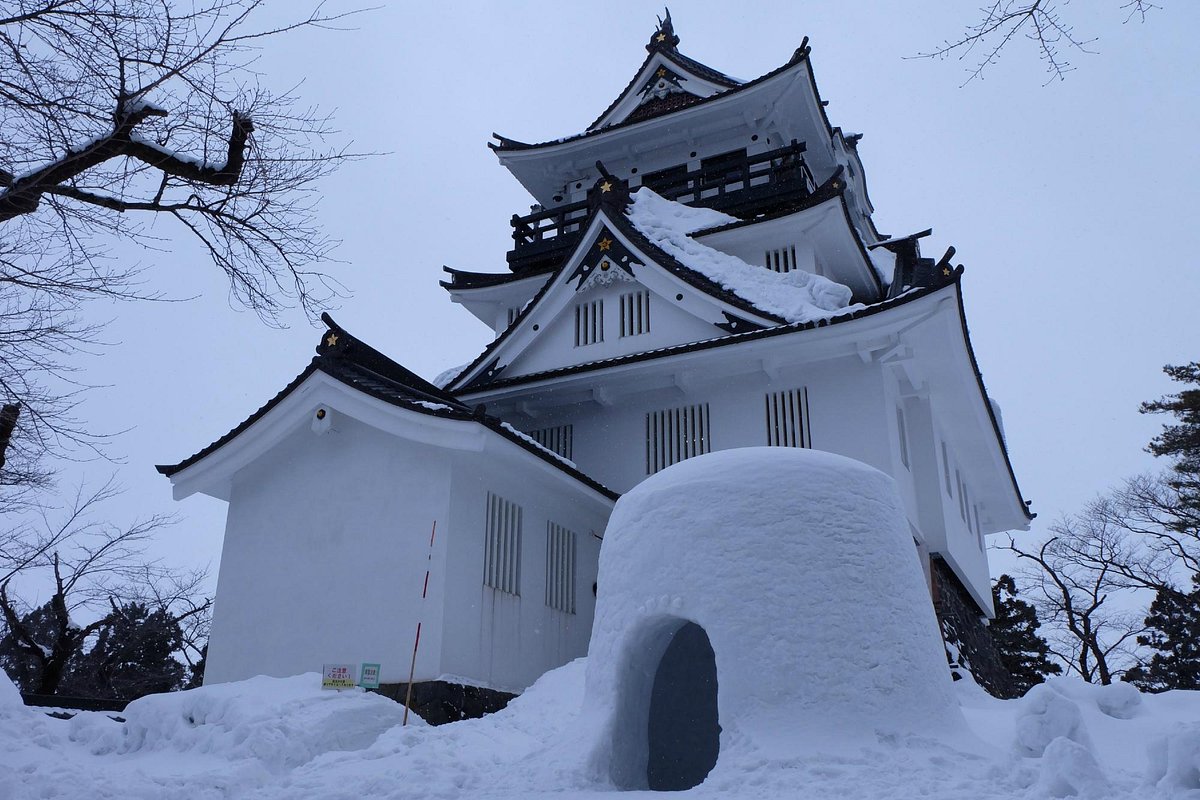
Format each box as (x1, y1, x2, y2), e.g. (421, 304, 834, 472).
(612, 618, 721, 792)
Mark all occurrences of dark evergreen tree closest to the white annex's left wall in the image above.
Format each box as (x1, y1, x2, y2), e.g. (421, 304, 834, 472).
(61, 602, 186, 700)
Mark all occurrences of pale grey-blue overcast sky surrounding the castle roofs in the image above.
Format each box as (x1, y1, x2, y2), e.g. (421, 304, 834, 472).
(28, 0, 1200, 597)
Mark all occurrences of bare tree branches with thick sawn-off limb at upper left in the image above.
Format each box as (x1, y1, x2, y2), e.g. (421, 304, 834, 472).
(0, 0, 358, 482)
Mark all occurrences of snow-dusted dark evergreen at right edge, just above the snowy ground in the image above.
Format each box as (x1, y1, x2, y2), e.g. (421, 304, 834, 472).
(1124, 575, 1200, 692)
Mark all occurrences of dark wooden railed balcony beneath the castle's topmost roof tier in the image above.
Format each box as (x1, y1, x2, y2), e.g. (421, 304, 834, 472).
(508, 142, 816, 273)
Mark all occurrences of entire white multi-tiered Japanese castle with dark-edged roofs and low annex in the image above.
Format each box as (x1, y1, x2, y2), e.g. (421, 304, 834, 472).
(161, 10, 1031, 694)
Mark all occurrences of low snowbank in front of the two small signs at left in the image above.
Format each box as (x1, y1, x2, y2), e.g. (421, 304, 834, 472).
(71, 673, 412, 774)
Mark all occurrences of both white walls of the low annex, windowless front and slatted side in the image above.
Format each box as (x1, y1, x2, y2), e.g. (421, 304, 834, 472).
(205, 398, 612, 691)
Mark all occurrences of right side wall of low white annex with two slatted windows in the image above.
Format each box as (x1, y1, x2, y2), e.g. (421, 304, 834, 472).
(440, 453, 611, 691)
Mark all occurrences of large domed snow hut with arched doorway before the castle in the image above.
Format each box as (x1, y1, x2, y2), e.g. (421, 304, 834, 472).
(586, 447, 966, 788)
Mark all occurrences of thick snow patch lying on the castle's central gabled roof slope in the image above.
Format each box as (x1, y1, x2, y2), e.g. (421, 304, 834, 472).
(628, 186, 860, 323)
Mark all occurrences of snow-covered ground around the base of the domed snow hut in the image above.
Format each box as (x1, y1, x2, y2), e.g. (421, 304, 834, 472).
(0, 660, 1200, 800)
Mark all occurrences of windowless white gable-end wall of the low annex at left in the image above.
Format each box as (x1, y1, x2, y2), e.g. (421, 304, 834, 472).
(205, 411, 450, 684)
